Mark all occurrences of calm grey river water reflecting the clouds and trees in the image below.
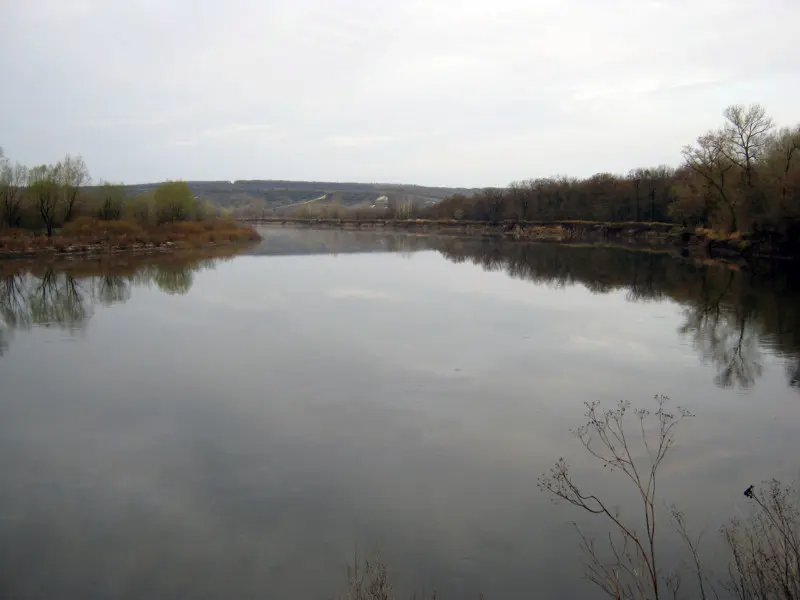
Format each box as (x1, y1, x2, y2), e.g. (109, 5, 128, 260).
(0, 230, 800, 600)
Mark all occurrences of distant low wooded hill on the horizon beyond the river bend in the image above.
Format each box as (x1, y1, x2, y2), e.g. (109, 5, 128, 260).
(125, 179, 477, 216)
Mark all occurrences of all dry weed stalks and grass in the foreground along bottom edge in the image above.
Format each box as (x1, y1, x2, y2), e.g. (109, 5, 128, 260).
(341, 396, 800, 600)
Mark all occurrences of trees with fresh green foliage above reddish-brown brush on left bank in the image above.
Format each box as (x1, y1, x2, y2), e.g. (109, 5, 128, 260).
(0, 148, 218, 237)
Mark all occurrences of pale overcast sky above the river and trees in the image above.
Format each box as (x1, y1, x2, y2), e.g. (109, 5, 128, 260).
(0, 0, 800, 186)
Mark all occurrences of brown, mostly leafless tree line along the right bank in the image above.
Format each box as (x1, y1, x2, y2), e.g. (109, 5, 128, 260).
(417, 104, 800, 236)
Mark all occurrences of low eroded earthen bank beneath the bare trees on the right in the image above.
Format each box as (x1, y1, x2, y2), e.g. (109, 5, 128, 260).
(246, 218, 798, 259)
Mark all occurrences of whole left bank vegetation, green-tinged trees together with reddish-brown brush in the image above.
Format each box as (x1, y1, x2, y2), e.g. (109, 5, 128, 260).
(0, 149, 259, 257)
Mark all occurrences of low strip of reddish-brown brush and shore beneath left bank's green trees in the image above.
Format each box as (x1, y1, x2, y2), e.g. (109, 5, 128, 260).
(0, 217, 261, 259)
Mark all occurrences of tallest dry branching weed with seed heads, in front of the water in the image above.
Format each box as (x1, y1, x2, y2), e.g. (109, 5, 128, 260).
(539, 396, 692, 600)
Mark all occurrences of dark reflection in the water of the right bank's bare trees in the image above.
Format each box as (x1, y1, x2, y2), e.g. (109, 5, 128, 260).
(432, 239, 800, 389)
